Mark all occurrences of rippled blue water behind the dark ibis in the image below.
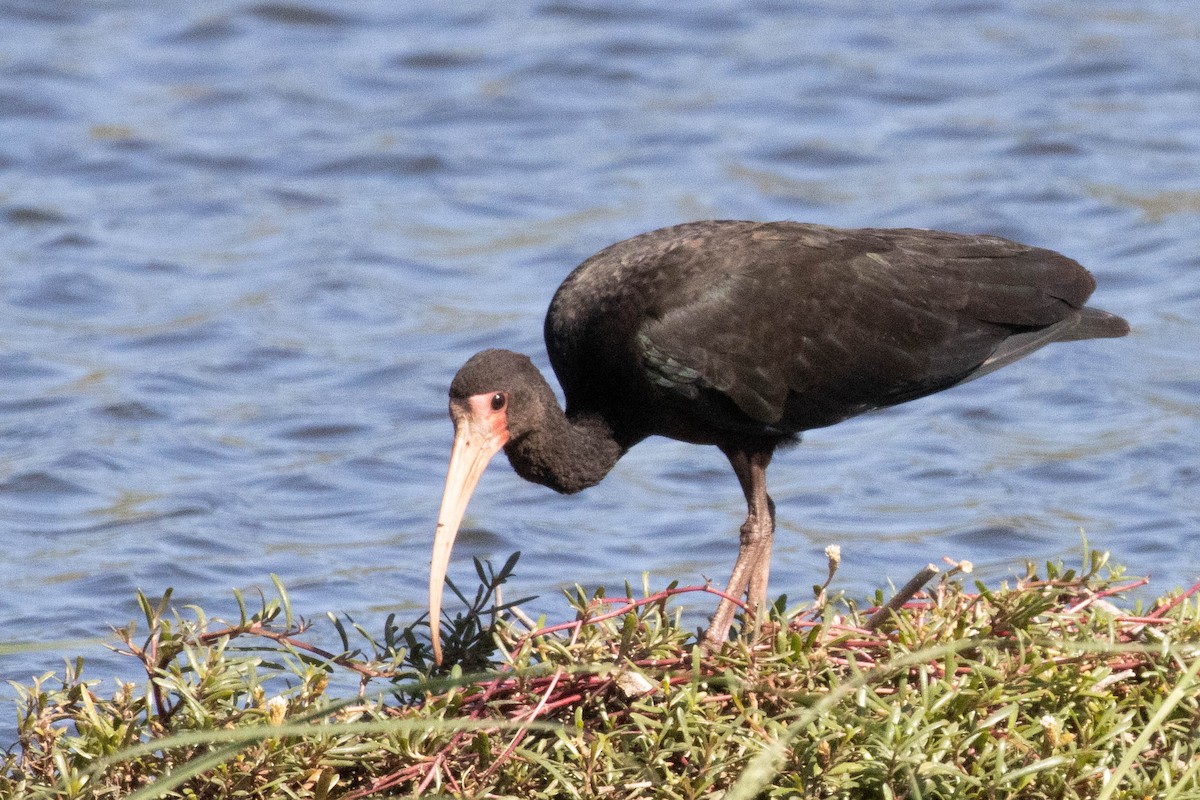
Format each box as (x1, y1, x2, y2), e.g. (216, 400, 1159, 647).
(0, 0, 1200, 734)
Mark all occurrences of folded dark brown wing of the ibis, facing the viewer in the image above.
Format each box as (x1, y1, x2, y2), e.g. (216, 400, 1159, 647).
(637, 224, 1094, 434)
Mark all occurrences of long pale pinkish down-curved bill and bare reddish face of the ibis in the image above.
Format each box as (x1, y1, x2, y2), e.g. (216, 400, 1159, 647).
(430, 395, 509, 663)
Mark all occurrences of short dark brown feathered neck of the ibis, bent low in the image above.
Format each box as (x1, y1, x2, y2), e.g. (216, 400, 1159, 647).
(504, 410, 625, 494)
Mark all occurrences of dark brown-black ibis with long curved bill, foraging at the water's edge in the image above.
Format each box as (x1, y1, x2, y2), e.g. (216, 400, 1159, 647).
(430, 221, 1129, 663)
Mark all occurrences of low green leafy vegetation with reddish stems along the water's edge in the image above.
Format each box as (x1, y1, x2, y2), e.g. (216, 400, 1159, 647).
(0, 552, 1200, 800)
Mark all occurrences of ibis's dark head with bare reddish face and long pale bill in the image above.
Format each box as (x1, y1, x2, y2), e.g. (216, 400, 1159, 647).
(430, 350, 545, 663)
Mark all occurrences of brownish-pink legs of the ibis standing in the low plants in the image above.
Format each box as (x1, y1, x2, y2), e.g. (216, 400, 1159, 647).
(704, 449, 775, 646)
